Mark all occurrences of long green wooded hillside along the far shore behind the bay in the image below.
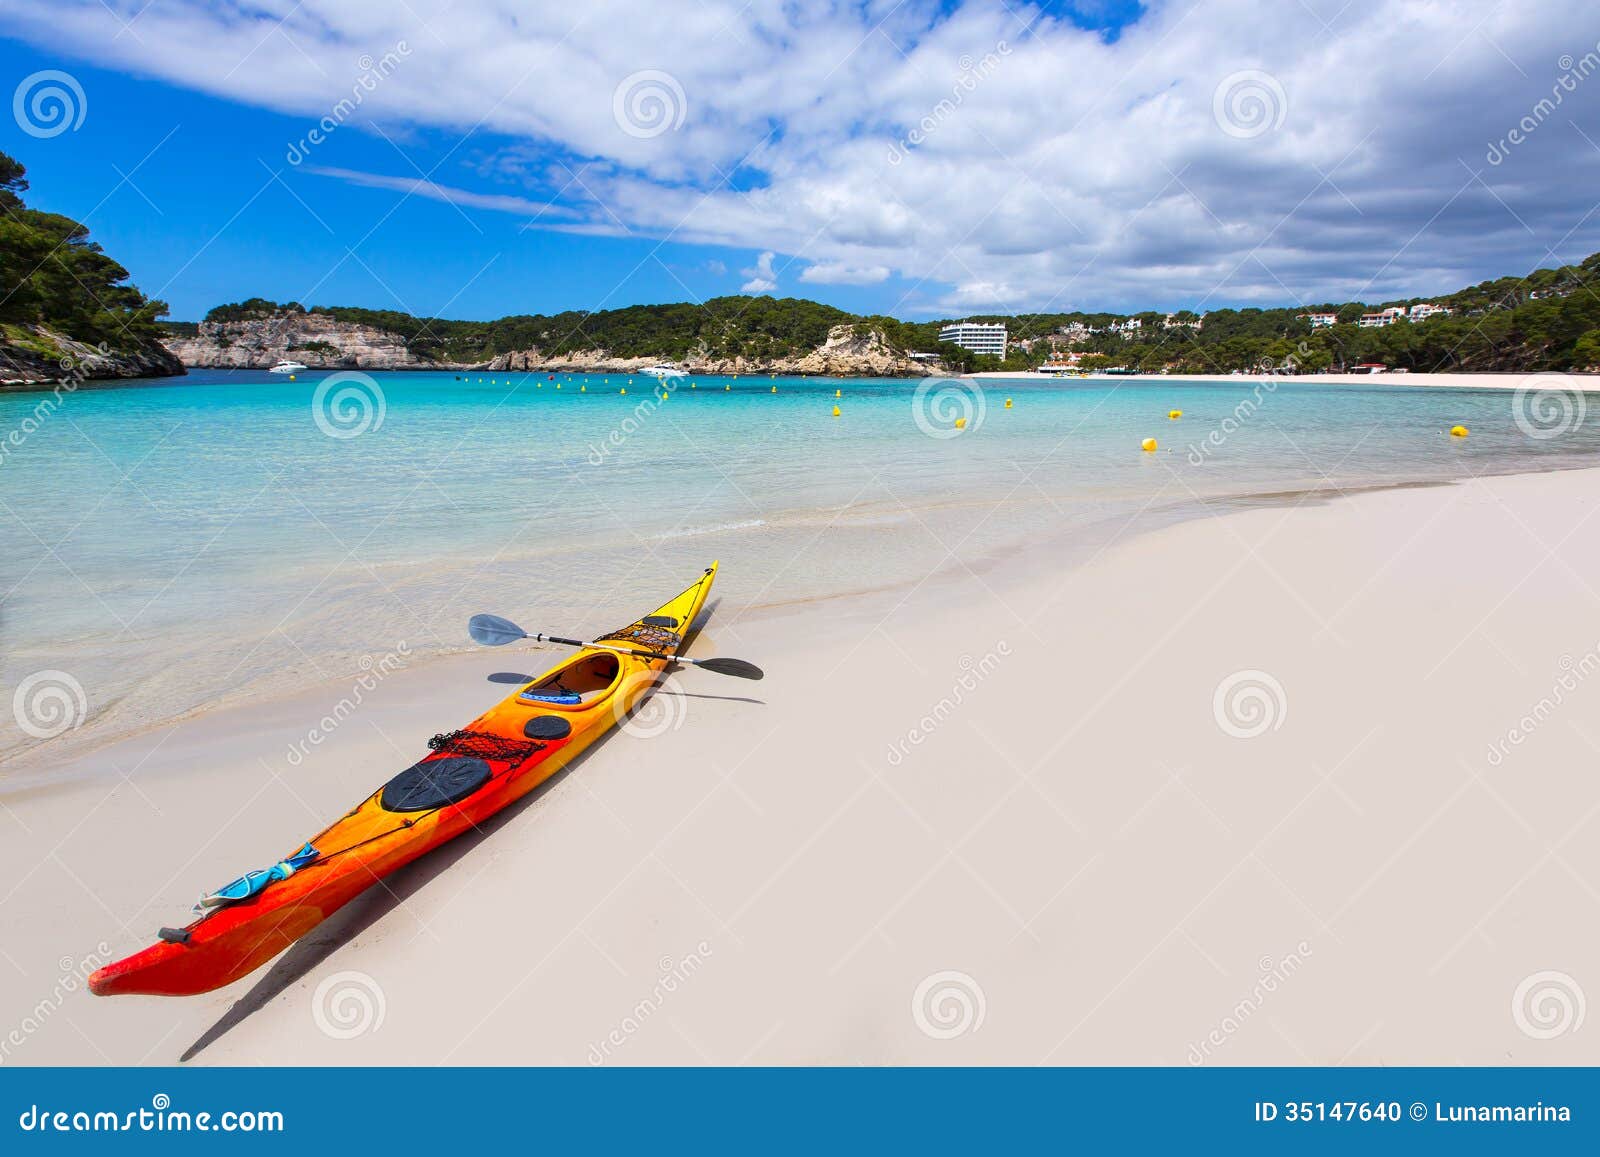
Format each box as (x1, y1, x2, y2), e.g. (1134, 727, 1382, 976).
(193, 254, 1600, 373)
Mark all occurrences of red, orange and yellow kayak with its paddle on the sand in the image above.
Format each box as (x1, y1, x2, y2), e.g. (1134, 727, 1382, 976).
(90, 563, 762, 995)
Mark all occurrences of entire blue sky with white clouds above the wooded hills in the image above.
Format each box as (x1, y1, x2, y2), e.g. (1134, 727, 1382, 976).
(0, 0, 1600, 320)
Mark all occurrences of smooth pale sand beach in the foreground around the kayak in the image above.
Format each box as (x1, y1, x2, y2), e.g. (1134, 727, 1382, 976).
(0, 467, 1600, 1064)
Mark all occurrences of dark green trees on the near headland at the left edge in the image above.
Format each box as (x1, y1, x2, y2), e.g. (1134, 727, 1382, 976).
(0, 152, 166, 357)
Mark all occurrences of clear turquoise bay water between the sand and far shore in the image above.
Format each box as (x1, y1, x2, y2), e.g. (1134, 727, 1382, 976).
(0, 371, 1600, 768)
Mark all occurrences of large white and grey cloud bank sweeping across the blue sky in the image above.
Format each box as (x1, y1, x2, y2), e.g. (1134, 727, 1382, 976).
(12, 0, 1600, 309)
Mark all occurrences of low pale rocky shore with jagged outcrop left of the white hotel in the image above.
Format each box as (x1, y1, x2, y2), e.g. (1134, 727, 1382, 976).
(483, 325, 946, 378)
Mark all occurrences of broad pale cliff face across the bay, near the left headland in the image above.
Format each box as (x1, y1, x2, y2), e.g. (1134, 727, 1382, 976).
(166, 314, 450, 370)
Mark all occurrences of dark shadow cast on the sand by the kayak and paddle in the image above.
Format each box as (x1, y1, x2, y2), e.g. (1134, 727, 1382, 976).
(178, 607, 752, 1061)
